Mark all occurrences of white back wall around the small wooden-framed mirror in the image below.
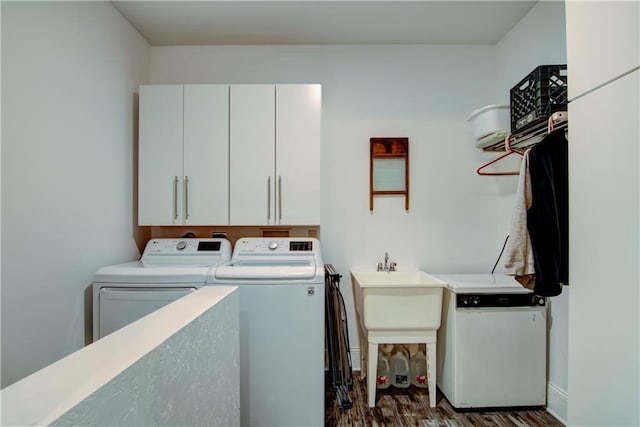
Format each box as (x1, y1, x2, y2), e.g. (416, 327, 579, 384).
(151, 46, 515, 374)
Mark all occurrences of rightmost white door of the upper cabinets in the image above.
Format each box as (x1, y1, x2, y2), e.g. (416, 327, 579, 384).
(276, 84, 322, 225)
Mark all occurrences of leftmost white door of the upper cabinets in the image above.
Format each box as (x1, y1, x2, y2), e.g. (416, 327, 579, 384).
(138, 85, 182, 225)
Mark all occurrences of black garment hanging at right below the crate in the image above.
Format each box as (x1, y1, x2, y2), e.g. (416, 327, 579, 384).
(527, 129, 569, 296)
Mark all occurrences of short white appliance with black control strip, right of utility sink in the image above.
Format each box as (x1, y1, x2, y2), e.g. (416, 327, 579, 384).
(435, 274, 547, 408)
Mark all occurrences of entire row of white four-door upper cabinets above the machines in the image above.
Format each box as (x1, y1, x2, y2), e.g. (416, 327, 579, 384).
(138, 84, 322, 225)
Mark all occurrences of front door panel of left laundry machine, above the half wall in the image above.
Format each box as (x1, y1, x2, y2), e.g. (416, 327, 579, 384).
(94, 287, 197, 339)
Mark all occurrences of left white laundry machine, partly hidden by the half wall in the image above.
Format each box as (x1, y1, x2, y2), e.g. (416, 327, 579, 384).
(93, 238, 231, 341)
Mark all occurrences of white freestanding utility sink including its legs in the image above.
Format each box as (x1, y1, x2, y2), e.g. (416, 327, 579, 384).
(351, 269, 447, 407)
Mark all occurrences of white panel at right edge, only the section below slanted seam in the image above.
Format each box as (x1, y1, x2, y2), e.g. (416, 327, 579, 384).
(568, 68, 640, 426)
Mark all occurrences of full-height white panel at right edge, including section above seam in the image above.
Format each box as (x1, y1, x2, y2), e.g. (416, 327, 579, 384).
(566, 1, 640, 426)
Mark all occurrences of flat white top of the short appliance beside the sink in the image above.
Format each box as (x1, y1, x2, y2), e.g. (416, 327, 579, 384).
(433, 274, 532, 294)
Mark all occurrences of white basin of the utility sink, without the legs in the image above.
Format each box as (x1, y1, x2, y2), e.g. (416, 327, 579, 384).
(351, 270, 446, 333)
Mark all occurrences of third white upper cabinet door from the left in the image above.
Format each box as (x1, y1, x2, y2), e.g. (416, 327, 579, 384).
(229, 85, 276, 225)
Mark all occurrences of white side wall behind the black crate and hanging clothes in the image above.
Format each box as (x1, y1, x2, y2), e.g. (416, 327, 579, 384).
(496, 1, 571, 420)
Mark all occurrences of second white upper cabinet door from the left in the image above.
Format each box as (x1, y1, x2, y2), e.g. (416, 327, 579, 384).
(181, 85, 229, 225)
